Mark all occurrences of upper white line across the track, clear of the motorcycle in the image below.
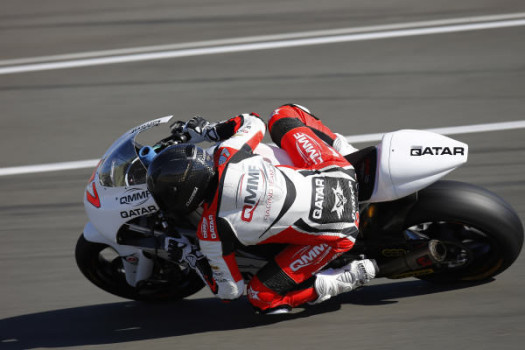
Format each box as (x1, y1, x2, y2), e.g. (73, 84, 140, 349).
(0, 13, 525, 75)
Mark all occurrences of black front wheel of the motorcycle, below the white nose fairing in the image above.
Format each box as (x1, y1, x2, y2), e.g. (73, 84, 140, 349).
(75, 234, 204, 301)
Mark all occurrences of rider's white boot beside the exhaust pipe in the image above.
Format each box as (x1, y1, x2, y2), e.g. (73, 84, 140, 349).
(312, 259, 379, 304)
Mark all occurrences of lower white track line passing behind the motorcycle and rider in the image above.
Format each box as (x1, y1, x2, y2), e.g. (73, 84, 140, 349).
(0, 120, 525, 176)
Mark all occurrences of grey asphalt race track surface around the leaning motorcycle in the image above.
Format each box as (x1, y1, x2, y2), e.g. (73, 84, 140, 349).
(0, 0, 525, 349)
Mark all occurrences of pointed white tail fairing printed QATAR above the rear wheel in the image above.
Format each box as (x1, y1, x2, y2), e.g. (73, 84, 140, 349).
(368, 130, 468, 202)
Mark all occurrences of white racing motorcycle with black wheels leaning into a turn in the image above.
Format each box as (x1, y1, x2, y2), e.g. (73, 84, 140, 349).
(75, 116, 523, 301)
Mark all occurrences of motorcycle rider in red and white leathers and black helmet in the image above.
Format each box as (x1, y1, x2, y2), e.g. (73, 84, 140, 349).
(147, 104, 377, 314)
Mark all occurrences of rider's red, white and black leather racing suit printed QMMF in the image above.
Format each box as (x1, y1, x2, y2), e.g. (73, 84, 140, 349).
(197, 105, 359, 311)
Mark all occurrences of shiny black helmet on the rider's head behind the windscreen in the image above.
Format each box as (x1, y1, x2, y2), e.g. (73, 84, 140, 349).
(147, 144, 215, 214)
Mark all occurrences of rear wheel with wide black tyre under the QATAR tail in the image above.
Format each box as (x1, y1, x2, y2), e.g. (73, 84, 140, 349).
(405, 181, 523, 283)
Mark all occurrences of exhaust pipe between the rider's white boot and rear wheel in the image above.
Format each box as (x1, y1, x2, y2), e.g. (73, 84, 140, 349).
(378, 239, 447, 278)
